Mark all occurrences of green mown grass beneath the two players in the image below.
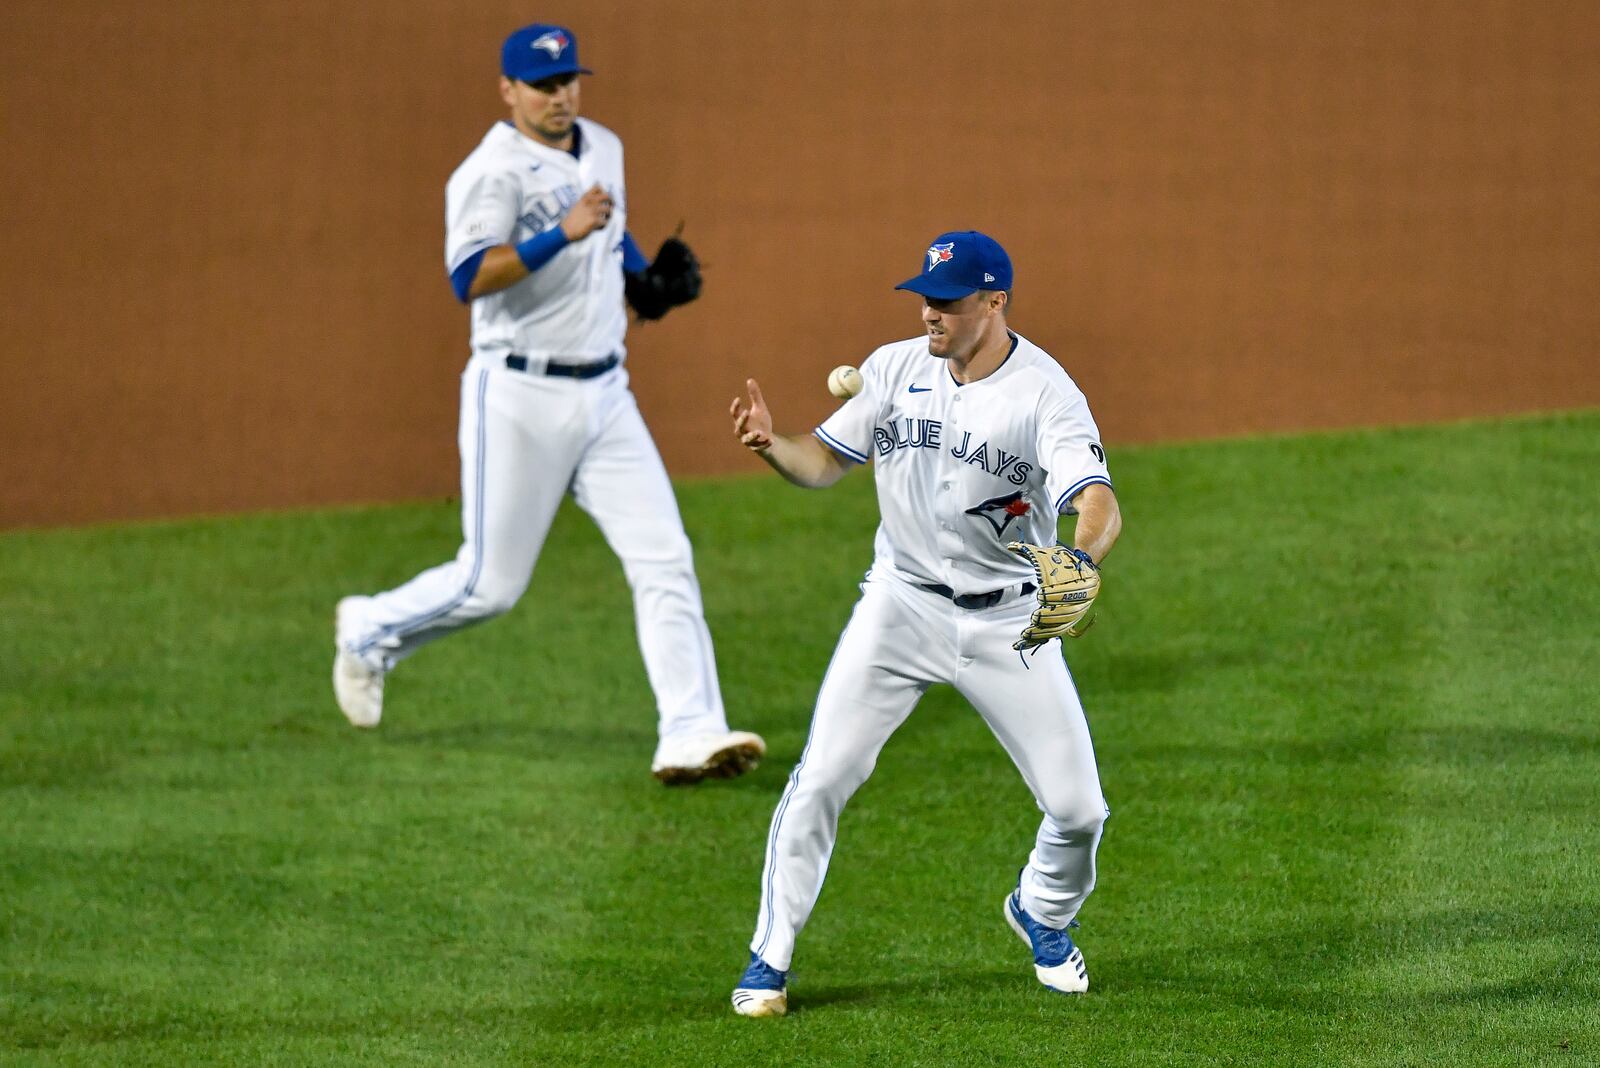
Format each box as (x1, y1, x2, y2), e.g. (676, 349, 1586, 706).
(0, 412, 1600, 1066)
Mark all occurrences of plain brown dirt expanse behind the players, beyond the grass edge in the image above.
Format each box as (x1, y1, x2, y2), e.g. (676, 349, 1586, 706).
(0, 0, 1600, 526)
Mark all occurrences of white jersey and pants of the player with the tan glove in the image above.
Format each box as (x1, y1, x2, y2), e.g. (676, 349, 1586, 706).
(734, 327, 1110, 984)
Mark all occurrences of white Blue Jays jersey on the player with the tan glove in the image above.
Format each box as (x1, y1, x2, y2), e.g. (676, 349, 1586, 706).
(816, 334, 1110, 593)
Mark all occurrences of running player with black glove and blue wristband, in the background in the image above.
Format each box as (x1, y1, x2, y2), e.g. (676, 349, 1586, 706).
(333, 24, 766, 783)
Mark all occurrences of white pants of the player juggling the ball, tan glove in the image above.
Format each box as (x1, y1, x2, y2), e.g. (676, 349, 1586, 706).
(750, 576, 1107, 970)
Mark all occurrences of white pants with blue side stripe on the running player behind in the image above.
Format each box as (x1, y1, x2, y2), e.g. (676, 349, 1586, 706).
(349, 358, 728, 737)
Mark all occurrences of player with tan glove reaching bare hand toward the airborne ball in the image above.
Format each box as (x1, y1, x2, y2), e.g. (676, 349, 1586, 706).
(731, 230, 1122, 1017)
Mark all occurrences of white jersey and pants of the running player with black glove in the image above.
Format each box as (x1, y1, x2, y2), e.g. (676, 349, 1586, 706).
(339, 106, 728, 742)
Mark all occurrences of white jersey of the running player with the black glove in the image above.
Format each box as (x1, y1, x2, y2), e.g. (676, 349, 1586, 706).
(445, 118, 627, 361)
